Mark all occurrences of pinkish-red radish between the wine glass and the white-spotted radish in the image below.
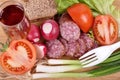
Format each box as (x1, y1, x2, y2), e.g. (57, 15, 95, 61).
(27, 24, 41, 43)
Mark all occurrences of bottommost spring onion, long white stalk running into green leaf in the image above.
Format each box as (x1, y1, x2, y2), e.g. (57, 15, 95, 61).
(32, 64, 120, 79)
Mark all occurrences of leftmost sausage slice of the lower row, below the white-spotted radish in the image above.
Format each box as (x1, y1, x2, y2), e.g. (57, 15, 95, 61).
(46, 39, 65, 58)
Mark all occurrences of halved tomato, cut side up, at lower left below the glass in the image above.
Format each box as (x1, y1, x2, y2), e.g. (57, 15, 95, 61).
(1, 39, 36, 74)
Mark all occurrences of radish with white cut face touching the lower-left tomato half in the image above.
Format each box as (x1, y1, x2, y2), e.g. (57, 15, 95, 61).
(34, 43, 47, 59)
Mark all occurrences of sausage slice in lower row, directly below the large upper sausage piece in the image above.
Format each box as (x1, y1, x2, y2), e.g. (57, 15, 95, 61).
(66, 41, 80, 57)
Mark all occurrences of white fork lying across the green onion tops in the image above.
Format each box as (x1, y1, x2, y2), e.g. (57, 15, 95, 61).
(79, 41, 120, 67)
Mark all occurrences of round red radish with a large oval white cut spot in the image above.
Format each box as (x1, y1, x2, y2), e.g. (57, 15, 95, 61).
(41, 20, 59, 40)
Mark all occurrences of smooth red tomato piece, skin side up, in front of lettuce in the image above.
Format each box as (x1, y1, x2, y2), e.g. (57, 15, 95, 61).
(67, 3, 93, 32)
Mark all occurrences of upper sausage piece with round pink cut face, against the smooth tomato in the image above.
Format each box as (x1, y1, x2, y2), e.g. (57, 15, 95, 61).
(59, 14, 80, 41)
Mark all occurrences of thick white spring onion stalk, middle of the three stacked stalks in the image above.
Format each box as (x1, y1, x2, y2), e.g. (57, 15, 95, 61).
(36, 64, 82, 73)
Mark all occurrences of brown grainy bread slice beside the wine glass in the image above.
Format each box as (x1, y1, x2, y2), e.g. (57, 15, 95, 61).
(17, 0, 57, 20)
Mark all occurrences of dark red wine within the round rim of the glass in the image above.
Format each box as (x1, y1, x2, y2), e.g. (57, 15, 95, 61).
(0, 5, 24, 26)
